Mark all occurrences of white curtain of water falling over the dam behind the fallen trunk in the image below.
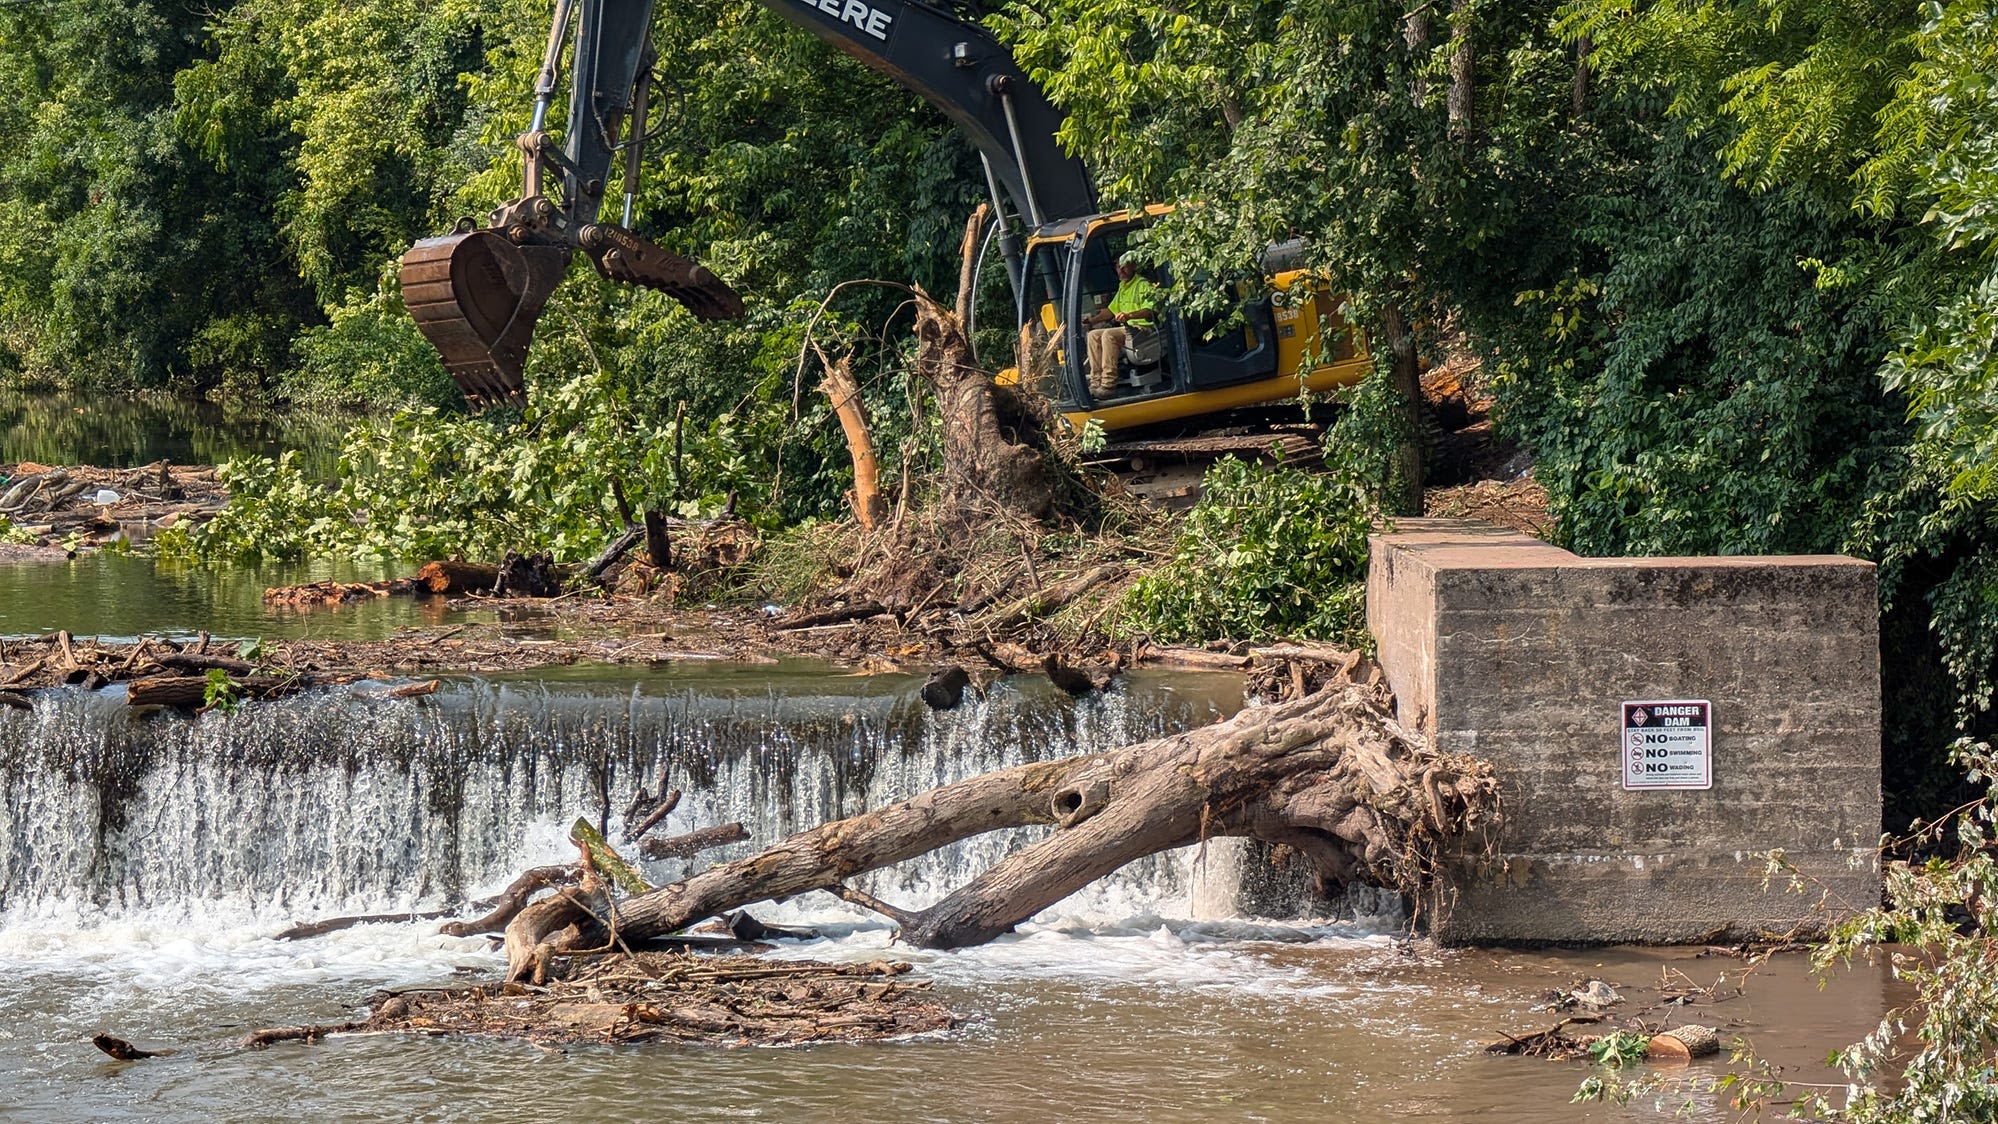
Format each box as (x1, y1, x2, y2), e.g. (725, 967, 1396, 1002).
(0, 669, 1239, 922)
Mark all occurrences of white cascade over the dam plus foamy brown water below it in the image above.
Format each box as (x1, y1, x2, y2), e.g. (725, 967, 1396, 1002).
(0, 667, 1888, 1122)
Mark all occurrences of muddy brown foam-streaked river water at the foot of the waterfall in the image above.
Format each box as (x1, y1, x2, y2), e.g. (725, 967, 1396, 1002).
(0, 922, 1886, 1124)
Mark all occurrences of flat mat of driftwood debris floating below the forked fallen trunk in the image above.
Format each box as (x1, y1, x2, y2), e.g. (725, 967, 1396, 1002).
(244, 952, 961, 1048)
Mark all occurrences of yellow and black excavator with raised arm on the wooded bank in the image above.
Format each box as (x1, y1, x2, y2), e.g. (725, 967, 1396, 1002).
(402, 0, 1369, 445)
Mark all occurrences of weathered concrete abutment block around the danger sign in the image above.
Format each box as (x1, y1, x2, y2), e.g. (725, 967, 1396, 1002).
(1367, 519, 1880, 944)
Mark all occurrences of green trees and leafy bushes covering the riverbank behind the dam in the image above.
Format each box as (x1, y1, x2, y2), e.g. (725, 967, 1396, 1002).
(0, 0, 1998, 1110)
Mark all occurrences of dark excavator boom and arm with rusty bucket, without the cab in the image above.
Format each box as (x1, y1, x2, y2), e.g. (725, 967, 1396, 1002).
(402, 0, 1095, 403)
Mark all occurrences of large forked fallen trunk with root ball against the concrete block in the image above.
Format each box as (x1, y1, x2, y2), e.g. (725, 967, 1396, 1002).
(617, 687, 1497, 948)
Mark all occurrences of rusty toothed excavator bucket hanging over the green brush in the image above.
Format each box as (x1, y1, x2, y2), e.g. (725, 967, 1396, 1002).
(402, 230, 569, 405)
